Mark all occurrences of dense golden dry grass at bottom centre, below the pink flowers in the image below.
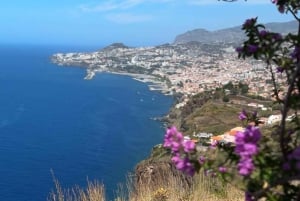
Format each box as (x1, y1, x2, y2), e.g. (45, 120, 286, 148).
(129, 170, 244, 201)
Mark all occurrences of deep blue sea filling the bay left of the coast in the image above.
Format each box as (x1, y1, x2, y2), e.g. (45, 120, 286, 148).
(0, 45, 173, 201)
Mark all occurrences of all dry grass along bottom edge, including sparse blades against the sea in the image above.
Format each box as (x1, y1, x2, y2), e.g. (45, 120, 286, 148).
(48, 170, 244, 201)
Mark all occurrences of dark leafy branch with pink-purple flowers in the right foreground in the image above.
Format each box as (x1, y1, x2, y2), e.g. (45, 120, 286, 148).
(164, 0, 300, 201)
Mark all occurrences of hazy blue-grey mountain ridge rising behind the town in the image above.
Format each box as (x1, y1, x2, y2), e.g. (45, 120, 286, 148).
(174, 21, 298, 44)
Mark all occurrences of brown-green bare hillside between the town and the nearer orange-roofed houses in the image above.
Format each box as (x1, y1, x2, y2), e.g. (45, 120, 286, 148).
(167, 92, 274, 135)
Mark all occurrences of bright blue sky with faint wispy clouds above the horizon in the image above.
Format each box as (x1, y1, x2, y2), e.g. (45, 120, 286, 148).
(0, 0, 293, 47)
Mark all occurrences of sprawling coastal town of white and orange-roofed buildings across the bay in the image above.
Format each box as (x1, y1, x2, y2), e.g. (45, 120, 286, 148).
(52, 42, 284, 98)
